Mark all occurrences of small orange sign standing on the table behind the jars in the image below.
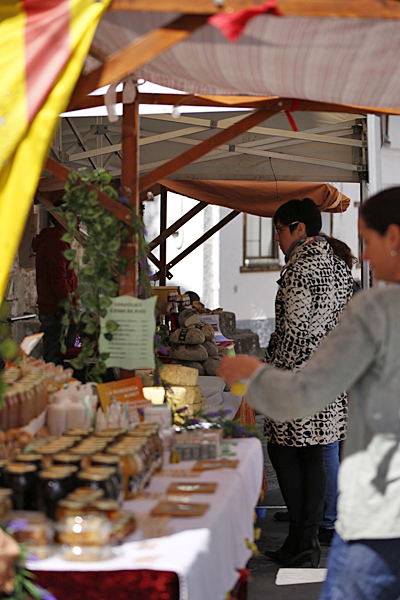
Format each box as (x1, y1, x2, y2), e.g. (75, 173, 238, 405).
(97, 377, 151, 425)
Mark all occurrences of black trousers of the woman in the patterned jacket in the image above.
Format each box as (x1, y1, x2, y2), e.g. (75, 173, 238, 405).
(268, 442, 326, 539)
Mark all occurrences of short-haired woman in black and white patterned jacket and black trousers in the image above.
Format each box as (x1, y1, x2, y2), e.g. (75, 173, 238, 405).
(265, 198, 353, 565)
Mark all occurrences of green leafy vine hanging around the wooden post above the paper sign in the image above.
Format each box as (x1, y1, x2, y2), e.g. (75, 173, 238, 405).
(57, 169, 163, 383)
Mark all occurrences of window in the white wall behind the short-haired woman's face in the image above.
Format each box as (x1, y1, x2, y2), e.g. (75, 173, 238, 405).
(241, 214, 279, 273)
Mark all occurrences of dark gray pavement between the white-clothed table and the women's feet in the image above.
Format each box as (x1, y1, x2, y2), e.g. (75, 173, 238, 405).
(248, 426, 329, 600)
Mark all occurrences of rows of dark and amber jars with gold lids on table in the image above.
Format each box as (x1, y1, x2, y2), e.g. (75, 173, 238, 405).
(0, 423, 163, 520)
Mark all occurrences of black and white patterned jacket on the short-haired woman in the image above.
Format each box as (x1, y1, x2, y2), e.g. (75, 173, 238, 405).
(265, 236, 353, 446)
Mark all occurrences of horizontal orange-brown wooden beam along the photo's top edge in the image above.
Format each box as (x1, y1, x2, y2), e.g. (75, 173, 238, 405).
(109, 0, 400, 19)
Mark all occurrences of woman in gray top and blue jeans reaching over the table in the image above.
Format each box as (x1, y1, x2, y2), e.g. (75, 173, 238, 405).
(219, 187, 400, 600)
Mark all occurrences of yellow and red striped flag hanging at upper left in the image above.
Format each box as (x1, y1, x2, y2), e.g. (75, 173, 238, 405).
(0, 0, 110, 300)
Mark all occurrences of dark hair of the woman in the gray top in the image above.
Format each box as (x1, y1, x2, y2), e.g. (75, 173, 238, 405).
(360, 187, 400, 235)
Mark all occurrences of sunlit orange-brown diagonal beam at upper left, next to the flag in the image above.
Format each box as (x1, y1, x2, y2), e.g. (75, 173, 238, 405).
(67, 11, 207, 110)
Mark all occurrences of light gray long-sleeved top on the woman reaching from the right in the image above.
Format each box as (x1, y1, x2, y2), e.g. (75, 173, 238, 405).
(247, 284, 400, 540)
